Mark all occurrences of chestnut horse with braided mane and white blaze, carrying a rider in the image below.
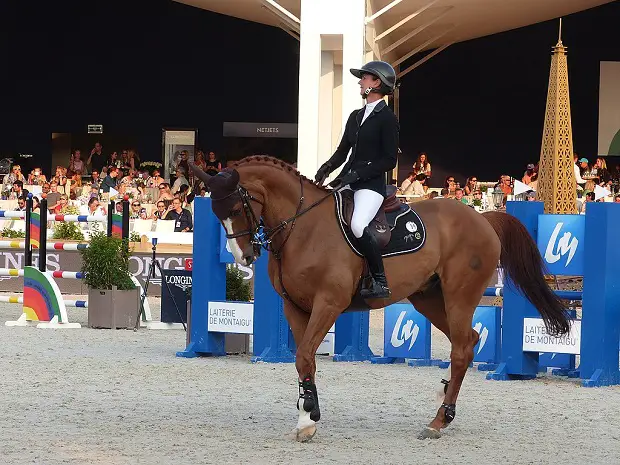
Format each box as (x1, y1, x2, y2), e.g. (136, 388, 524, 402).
(191, 156, 569, 441)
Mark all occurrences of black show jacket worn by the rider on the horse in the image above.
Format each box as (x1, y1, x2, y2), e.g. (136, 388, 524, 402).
(329, 100, 400, 197)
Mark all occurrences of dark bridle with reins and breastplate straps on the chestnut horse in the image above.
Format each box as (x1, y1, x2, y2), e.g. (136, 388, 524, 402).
(216, 177, 333, 312)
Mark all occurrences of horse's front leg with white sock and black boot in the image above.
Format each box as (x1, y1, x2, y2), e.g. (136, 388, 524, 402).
(295, 294, 346, 442)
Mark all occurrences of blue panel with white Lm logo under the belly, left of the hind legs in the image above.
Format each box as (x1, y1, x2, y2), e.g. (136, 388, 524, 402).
(371, 303, 431, 366)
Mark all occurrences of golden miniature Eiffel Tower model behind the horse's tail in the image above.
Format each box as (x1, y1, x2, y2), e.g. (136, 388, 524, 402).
(538, 18, 577, 214)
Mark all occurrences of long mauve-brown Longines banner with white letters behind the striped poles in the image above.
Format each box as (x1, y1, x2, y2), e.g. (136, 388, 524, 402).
(0, 250, 254, 296)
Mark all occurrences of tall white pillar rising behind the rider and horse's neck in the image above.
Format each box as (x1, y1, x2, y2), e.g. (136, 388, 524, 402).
(297, 0, 366, 177)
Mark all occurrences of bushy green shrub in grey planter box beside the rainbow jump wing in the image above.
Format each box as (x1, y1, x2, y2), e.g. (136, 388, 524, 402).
(80, 232, 135, 291)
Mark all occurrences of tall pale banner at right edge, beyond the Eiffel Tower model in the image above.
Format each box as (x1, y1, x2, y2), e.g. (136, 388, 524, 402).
(598, 61, 620, 155)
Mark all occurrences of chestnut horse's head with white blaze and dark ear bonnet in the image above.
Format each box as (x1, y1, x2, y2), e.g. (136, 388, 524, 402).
(189, 163, 262, 266)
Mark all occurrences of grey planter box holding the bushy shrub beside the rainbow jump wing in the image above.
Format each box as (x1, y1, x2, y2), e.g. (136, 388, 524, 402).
(88, 287, 140, 329)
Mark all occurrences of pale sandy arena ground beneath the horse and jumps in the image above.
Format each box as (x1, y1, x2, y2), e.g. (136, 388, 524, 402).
(0, 298, 620, 465)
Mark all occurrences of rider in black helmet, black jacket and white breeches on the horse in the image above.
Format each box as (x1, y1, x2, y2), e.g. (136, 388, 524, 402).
(315, 61, 400, 298)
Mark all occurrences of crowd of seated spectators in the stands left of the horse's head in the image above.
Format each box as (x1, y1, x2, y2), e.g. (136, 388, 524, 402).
(2, 142, 222, 232)
